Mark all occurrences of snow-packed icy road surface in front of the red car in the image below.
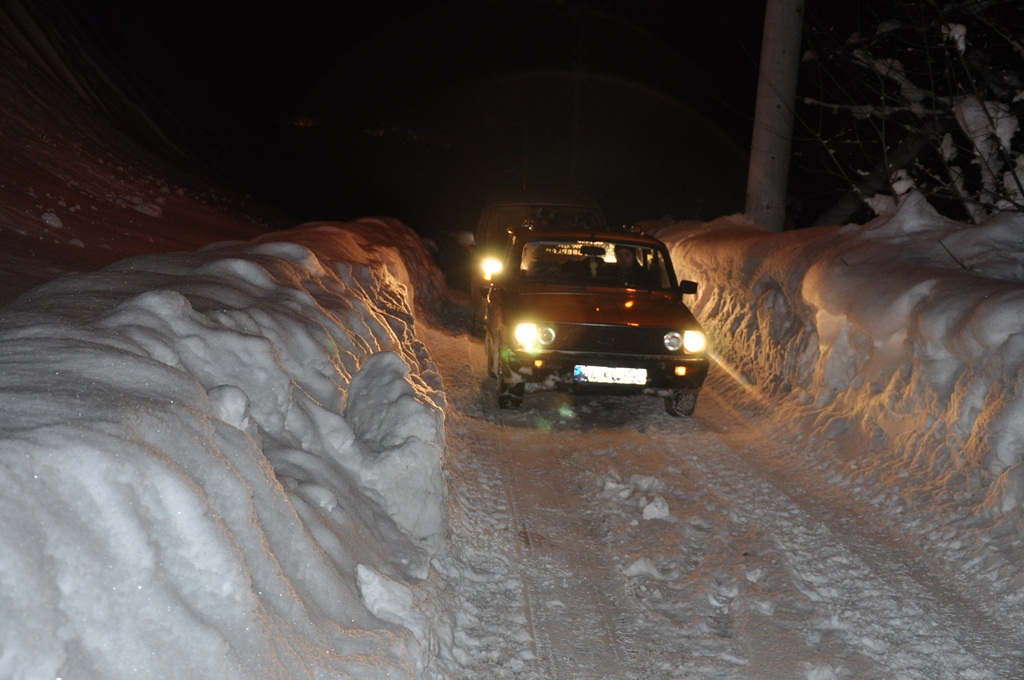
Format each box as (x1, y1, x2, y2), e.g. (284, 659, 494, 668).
(424, 331, 1024, 680)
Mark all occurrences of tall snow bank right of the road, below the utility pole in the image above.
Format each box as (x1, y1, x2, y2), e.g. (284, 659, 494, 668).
(658, 193, 1024, 585)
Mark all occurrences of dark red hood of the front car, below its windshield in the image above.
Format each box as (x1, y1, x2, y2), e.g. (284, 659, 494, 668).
(508, 287, 699, 328)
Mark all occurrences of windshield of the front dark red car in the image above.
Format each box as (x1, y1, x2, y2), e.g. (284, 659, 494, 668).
(519, 240, 673, 290)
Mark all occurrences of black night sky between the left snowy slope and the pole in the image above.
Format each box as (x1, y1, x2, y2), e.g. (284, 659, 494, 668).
(71, 0, 764, 231)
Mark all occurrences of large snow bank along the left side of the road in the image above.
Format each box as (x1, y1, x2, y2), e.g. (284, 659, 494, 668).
(0, 220, 451, 678)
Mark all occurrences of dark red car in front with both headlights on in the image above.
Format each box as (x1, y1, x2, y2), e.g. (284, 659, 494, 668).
(484, 228, 709, 416)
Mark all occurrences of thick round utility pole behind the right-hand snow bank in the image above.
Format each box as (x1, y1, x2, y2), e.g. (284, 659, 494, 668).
(746, 0, 804, 231)
